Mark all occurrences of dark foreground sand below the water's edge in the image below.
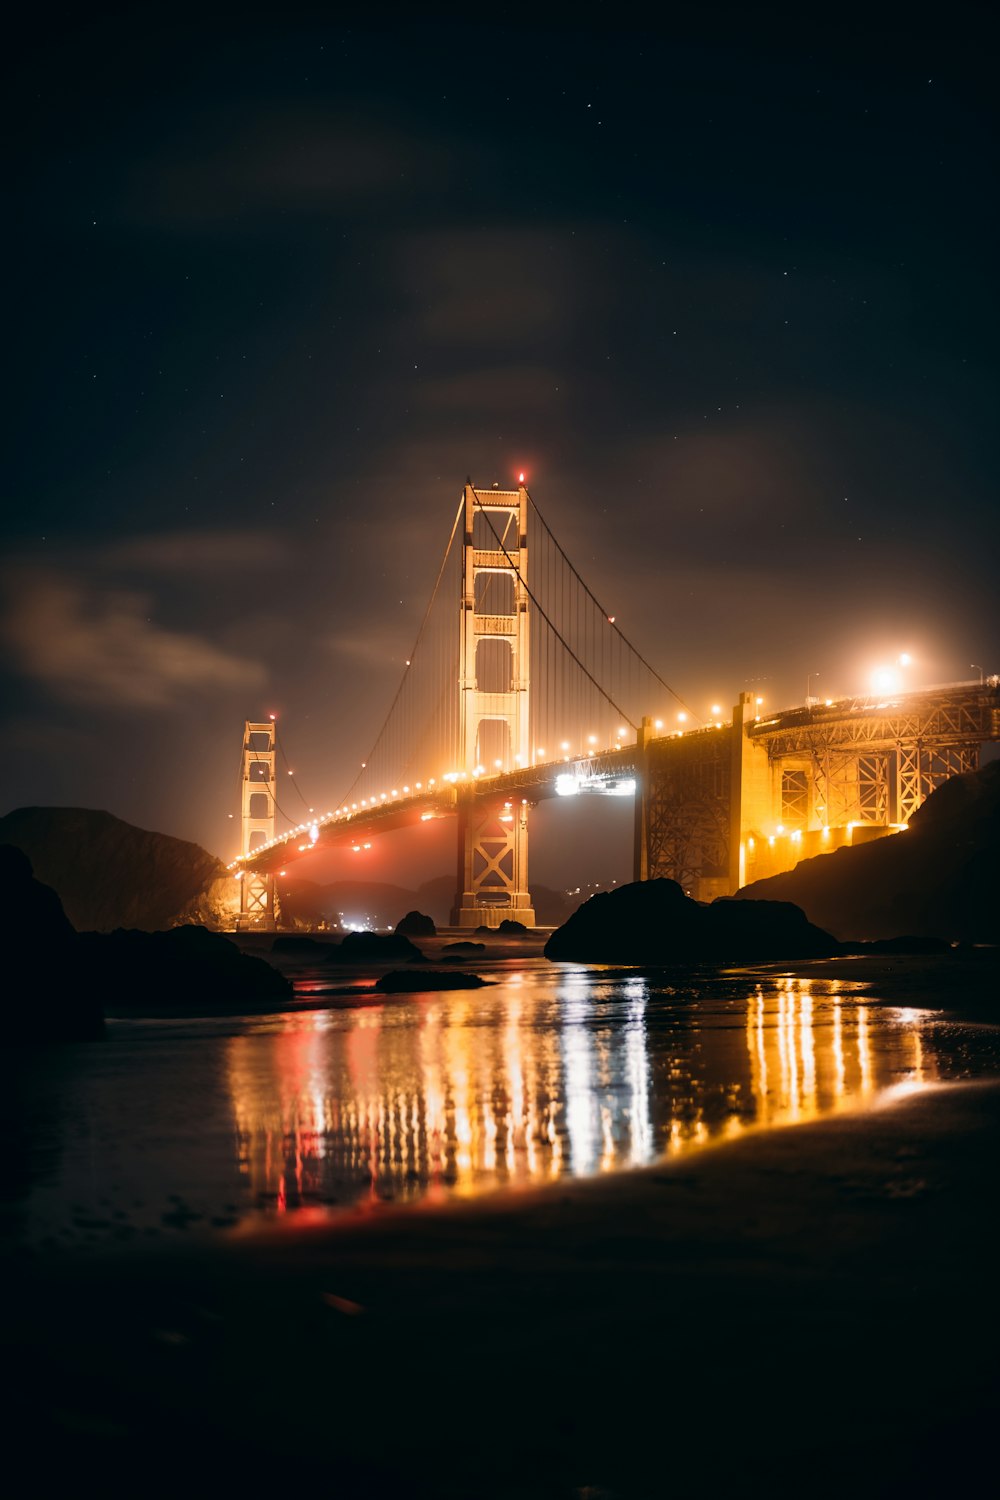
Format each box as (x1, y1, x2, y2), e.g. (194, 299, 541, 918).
(6, 1062, 1000, 1500)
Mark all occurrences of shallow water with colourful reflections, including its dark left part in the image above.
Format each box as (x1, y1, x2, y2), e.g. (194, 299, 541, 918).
(0, 960, 971, 1248)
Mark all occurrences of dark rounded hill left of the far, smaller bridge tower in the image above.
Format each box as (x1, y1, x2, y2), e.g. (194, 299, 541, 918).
(0, 807, 229, 932)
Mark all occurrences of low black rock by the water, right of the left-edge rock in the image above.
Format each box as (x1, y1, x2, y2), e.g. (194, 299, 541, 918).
(76, 927, 292, 1016)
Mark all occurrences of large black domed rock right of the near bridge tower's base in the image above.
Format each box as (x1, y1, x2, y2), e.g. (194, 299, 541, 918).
(544, 881, 841, 965)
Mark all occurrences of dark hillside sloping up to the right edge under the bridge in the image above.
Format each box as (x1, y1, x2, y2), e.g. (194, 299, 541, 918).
(738, 761, 1000, 942)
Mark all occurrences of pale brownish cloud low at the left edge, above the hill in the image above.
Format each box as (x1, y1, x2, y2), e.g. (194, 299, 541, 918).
(0, 570, 264, 710)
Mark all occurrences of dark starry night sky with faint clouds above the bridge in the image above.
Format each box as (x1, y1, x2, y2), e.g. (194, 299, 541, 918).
(1, 6, 1000, 884)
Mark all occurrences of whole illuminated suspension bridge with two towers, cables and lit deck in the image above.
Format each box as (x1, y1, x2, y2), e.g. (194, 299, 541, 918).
(229, 480, 1000, 929)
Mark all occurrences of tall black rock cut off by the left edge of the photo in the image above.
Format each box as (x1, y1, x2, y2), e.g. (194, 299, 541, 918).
(0, 845, 103, 1043)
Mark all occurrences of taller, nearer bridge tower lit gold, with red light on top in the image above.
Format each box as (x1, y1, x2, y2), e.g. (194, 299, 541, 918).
(451, 480, 535, 927)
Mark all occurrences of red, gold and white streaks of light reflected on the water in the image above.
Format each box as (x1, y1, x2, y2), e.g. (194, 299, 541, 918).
(228, 971, 937, 1212)
